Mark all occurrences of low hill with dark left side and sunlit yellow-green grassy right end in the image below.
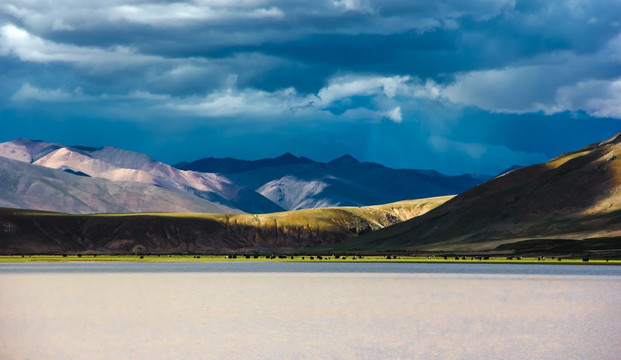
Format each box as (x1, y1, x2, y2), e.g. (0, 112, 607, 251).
(0, 196, 451, 254)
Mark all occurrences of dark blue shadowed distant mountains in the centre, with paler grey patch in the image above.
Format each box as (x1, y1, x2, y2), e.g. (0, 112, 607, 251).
(176, 154, 491, 210)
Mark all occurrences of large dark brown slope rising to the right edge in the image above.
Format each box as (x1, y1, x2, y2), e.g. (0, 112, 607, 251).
(346, 134, 621, 251)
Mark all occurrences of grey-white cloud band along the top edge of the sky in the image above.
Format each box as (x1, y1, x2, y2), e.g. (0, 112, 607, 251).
(0, 0, 514, 42)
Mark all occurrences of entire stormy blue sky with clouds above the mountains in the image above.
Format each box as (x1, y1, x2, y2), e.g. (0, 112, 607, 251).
(0, 0, 621, 174)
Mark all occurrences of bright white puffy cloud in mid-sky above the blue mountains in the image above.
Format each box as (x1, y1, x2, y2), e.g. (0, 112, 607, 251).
(160, 75, 438, 119)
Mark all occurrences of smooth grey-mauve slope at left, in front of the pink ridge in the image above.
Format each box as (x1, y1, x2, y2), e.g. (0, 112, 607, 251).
(0, 157, 239, 213)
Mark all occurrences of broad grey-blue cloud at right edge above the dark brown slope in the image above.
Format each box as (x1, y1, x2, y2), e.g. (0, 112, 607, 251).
(438, 30, 621, 118)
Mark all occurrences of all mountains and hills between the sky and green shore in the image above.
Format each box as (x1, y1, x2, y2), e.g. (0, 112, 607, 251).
(0, 135, 621, 256)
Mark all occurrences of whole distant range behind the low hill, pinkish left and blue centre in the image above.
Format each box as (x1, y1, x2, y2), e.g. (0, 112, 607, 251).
(0, 139, 489, 214)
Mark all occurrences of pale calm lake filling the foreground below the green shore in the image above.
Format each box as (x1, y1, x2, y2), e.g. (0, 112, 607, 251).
(0, 262, 621, 360)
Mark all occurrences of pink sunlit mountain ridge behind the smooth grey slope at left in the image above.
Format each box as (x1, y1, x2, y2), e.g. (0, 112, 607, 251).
(0, 139, 283, 213)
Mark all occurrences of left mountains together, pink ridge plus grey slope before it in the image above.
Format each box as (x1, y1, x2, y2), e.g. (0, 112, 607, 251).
(0, 139, 282, 213)
